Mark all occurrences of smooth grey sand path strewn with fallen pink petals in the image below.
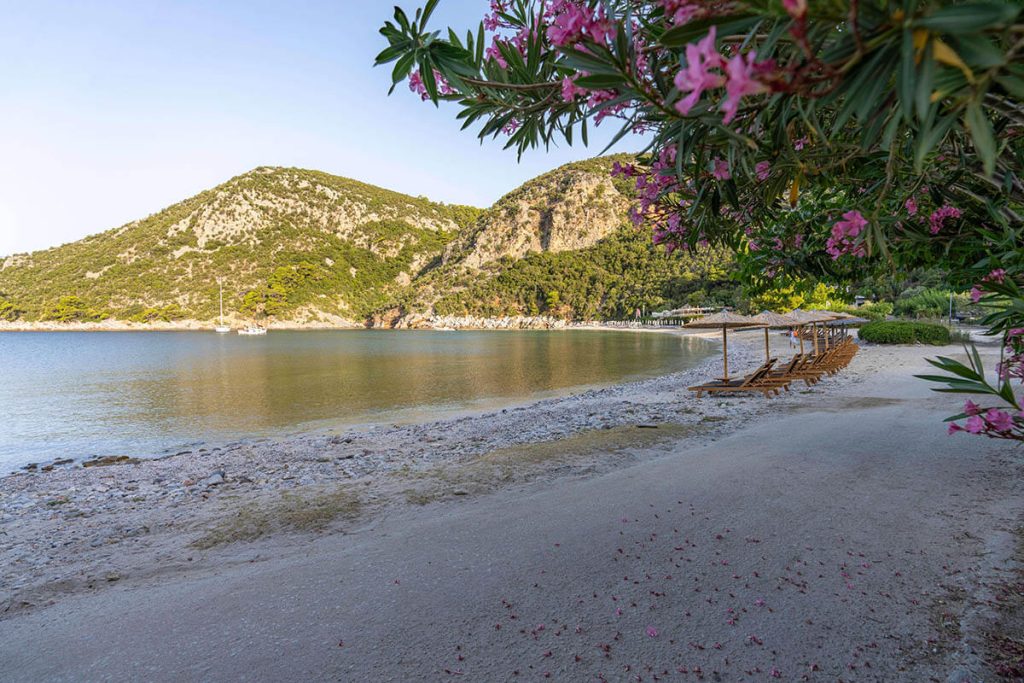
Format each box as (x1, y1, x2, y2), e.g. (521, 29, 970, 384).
(0, 348, 1024, 681)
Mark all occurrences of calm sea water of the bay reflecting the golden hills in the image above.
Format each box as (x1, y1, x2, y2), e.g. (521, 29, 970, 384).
(0, 331, 710, 472)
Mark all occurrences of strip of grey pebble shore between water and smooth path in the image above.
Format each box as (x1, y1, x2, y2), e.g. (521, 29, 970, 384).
(0, 341, 848, 618)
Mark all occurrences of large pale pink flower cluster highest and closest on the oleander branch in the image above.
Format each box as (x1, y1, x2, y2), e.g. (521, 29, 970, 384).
(675, 27, 774, 123)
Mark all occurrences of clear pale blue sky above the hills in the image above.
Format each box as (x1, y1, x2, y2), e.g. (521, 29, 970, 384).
(0, 0, 636, 255)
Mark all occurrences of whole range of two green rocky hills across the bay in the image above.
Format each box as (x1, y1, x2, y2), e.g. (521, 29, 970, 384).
(0, 158, 731, 325)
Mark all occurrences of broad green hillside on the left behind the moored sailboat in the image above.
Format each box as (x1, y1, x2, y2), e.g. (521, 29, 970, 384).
(0, 168, 479, 321)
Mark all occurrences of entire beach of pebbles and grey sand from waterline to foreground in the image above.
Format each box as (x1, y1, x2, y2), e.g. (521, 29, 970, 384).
(0, 333, 1024, 681)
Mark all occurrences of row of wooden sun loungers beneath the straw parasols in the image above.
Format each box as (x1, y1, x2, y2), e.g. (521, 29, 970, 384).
(689, 338, 860, 398)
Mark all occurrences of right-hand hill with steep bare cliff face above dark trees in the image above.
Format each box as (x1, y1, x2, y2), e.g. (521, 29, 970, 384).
(392, 155, 734, 319)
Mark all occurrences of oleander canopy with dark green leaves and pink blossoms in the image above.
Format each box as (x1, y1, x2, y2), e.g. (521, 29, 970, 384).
(377, 0, 1024, 438)
